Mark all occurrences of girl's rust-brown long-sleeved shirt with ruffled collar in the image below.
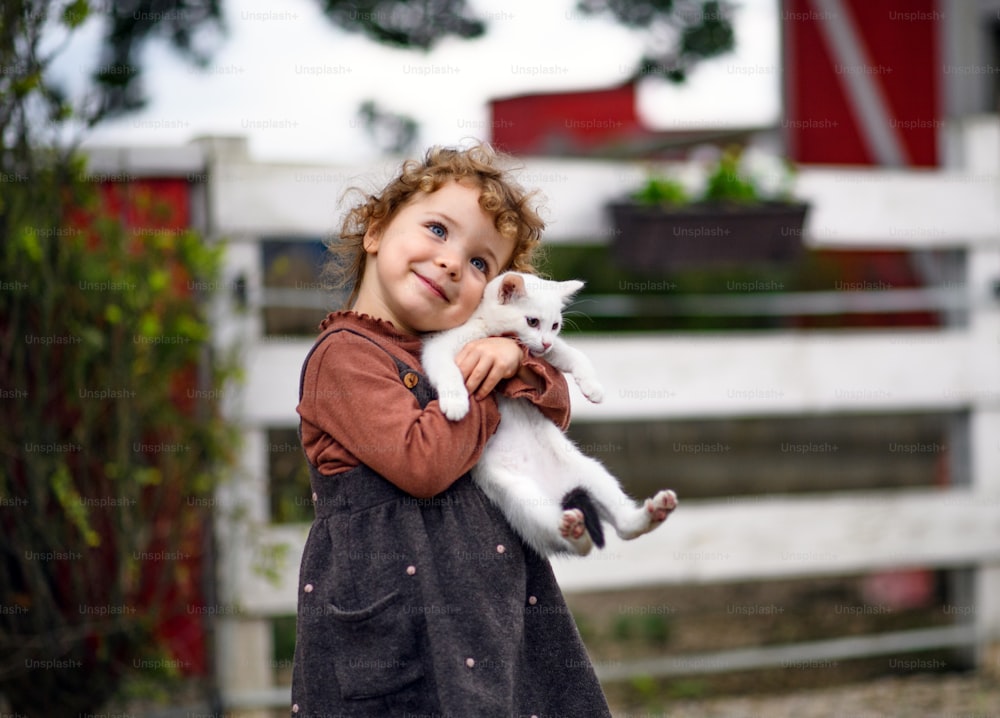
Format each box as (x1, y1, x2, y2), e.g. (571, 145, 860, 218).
(298, 311, 570, 498)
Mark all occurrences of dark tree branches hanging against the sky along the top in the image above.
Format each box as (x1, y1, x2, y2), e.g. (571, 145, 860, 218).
(0, 0, 735, 136)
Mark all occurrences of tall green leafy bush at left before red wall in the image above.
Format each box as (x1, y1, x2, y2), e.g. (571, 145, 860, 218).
(0, 151, 235, 715)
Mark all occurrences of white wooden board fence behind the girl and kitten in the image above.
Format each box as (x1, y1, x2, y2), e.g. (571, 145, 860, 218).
(143, 116, 1000, 709)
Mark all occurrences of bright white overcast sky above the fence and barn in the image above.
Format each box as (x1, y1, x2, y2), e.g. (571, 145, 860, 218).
(56, 0, 780, 164)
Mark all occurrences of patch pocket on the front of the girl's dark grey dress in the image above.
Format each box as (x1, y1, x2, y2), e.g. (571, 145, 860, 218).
(328, 591, 423, 700)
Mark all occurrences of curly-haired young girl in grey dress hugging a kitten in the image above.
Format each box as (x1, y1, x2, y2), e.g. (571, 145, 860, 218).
(292, 145, 610, 718)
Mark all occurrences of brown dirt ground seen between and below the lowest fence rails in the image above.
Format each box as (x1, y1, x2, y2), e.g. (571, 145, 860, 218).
(567, 572, 1000, 718)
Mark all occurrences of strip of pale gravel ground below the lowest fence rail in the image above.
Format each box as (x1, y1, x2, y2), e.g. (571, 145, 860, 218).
(614, 675, 1000, 718)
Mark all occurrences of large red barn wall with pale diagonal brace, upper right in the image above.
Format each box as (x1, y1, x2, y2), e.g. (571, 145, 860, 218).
(781, 0, 943, 167)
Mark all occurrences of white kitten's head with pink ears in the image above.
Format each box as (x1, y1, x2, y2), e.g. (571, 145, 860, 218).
(483, 272, 583, 356)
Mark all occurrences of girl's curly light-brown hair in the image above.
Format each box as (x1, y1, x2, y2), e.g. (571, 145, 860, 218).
(323, 143, 545, 308)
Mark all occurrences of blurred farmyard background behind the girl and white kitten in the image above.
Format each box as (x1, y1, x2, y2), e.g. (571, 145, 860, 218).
(0, 0, 1000, 716)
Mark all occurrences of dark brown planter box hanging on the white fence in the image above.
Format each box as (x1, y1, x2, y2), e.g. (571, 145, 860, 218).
(610, 202, 809, 271)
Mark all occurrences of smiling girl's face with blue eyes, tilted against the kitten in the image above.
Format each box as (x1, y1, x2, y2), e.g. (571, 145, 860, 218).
(353, 181, 514, 334)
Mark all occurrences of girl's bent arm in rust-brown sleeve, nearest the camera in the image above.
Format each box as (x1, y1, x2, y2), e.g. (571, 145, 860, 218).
(298, 332, 500, 498)
